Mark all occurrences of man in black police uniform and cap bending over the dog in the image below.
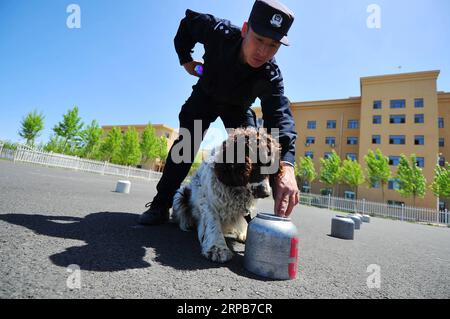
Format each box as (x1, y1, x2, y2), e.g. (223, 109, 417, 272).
(139, 0, 299, 225)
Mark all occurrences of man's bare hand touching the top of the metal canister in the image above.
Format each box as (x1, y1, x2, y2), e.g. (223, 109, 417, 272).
(274, 163, 300, 217)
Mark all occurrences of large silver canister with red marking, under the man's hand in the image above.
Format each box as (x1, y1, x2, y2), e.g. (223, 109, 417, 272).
(244, 213, 298, 280)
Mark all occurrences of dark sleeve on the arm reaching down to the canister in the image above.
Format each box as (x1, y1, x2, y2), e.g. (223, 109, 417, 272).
(259, 68, 297, 164)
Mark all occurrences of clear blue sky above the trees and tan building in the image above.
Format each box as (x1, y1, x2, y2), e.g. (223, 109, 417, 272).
(0, 0, 450, 148)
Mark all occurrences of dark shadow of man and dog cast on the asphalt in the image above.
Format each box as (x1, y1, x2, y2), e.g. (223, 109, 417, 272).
(0, 212, 264, 280)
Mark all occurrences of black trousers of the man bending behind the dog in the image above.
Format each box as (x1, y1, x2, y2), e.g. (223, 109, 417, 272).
(153, 85, 256, 207)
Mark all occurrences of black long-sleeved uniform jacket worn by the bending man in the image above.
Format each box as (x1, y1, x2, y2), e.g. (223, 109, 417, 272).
(174, 10, 297, 164)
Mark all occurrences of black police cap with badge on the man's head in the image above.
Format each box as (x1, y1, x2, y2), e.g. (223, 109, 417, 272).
(248, 0, 294, 45)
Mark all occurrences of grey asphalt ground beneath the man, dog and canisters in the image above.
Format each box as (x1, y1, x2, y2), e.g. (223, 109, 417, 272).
(0, 160, 450, 299)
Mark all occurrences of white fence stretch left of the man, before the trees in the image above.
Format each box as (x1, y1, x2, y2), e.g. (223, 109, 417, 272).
(0, 143, 162, 181)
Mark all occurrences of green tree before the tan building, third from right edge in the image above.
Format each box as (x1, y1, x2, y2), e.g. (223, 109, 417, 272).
(364, 149, 392, 203)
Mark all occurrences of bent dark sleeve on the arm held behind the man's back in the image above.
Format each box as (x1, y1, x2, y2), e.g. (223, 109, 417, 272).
(174, 9, 219, 65)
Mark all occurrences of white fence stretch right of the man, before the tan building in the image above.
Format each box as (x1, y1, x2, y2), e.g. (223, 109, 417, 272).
(300, 193, 450, 226)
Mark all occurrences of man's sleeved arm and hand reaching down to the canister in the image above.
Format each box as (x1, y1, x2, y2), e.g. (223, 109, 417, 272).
(260, 68, 299, 217)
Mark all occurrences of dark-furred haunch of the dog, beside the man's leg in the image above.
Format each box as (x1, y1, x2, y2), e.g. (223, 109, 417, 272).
(172, 186, 195, 231)
